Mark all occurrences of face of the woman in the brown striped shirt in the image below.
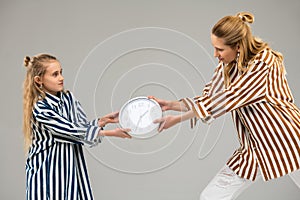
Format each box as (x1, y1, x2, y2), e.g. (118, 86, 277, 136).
(211, 34, 238, 64)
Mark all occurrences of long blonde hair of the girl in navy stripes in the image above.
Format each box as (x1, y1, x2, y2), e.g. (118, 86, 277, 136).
(23, 54, 57, 150)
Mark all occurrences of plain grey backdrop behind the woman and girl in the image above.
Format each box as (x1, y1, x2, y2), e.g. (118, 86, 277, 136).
(0, 0, 300, 200)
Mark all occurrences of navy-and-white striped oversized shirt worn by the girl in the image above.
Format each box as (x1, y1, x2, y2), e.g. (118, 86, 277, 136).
(26, 92, 101, 200)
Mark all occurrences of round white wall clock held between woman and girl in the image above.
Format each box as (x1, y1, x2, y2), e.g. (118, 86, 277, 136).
(119, 97, 162, 138)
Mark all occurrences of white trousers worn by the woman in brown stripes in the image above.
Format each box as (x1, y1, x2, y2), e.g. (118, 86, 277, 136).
(200, 165, 300, 200)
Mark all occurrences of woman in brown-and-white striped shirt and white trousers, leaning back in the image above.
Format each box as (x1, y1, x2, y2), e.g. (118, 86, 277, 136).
(150, 12, 300, 199)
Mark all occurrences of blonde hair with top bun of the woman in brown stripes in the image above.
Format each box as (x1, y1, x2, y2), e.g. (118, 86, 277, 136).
(212, 12, 283, 86)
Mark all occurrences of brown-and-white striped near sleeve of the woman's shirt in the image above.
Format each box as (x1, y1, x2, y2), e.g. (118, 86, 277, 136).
(182, 51, 269, 123)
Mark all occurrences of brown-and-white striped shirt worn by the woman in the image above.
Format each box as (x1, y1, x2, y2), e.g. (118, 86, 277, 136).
(182, 49, 300, 181)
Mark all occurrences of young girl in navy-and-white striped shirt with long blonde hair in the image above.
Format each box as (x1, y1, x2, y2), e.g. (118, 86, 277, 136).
(23, 54, 130, 200)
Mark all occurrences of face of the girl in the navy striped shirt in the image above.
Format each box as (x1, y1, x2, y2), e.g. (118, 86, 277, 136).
(35, 60, 64, 95)
